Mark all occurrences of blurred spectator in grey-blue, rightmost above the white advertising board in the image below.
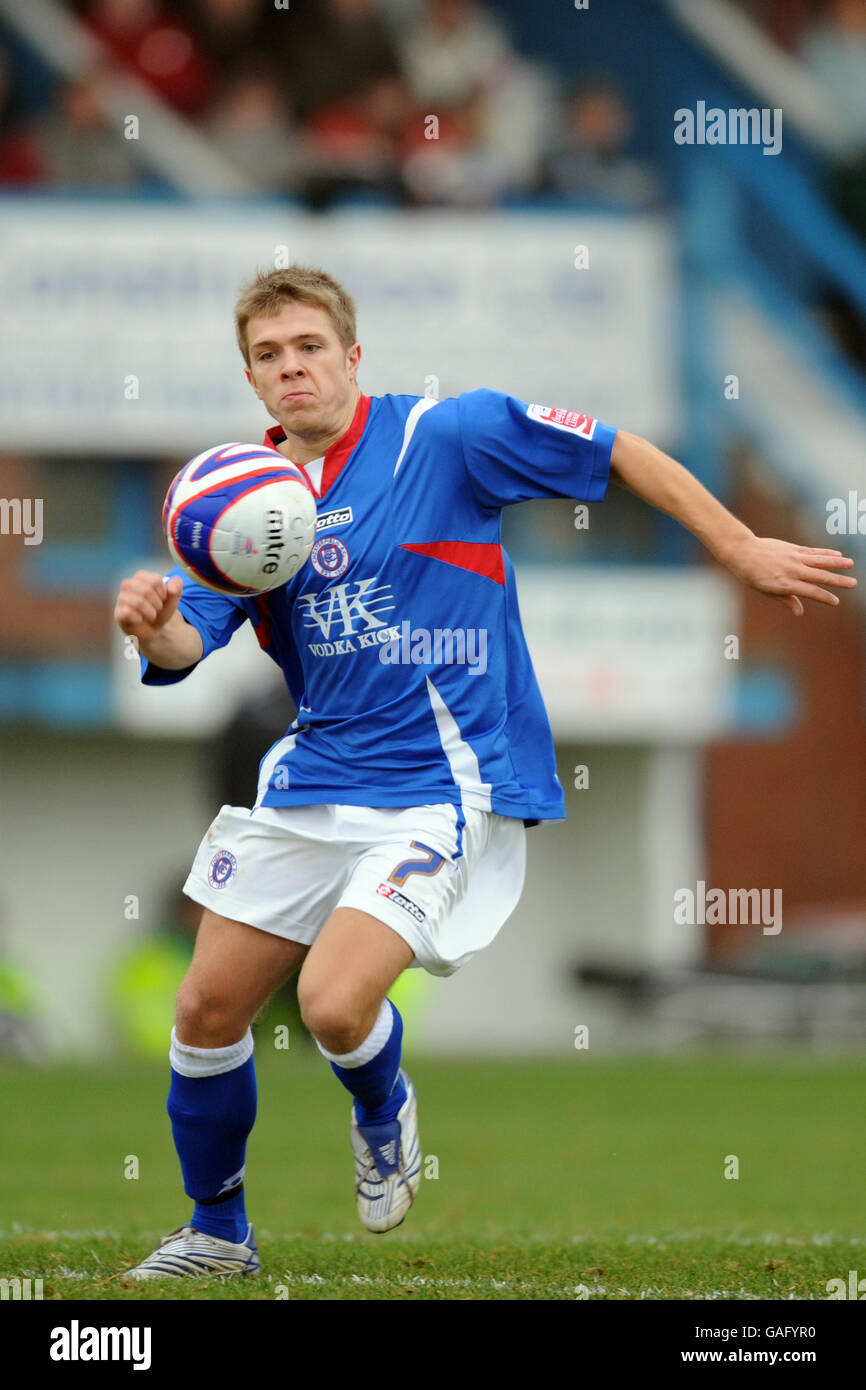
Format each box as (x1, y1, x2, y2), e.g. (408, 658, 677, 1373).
(541, 81, 659, 209)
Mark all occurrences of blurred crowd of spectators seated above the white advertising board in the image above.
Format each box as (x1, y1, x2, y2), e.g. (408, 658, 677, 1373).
(0, 0, 659, 209)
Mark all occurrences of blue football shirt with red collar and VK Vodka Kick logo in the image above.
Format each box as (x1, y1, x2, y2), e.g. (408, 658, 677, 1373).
(142, 389, 616, 823)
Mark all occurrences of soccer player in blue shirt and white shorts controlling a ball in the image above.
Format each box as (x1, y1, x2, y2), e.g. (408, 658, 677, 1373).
(114, 265, 856, 1279)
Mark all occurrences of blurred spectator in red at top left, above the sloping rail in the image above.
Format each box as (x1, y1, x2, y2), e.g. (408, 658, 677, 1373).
(83, 0, 211, 115)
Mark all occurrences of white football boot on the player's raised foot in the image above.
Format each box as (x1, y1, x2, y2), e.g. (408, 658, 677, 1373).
(352, 1072, 421, 1233)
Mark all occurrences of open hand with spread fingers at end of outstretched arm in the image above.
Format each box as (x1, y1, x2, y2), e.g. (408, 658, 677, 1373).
(728, 535, 858, 617)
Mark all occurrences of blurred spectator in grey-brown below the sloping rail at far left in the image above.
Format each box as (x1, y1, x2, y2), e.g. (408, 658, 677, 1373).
(36, 74, 142, 189)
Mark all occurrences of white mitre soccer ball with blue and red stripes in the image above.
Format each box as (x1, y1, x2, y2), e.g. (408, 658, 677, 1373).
(163, 443, 316, 596)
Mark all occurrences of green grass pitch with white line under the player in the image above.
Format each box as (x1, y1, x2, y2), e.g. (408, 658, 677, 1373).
(0, 1040, 866, 1301)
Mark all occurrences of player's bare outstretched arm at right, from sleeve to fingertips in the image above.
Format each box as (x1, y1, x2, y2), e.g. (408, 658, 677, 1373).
(610, 430, 856, 617)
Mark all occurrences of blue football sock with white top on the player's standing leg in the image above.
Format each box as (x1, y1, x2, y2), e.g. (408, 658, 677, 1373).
(168, 1033, 256, 1244)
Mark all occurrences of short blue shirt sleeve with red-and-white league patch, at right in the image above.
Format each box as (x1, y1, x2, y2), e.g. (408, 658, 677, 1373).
(457, 391, 616, 507)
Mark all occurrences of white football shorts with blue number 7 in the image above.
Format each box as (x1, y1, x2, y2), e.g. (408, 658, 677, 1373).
(183, 803, 525, 976)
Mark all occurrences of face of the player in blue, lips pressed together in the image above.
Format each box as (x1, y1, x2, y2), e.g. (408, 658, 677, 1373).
(246, 303, 361, 438)
